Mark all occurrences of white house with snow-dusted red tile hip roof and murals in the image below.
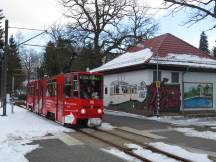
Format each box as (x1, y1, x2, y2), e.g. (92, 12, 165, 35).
(91, 33, 216, 111)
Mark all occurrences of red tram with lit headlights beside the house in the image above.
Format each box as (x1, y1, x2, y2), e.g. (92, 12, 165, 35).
(26, 72, 104, 126)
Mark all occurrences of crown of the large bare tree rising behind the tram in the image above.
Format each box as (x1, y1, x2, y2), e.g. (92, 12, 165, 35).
(61, 0, 157, 54)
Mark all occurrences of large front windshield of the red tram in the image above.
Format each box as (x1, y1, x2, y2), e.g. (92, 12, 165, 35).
(80, 75, 102, 99)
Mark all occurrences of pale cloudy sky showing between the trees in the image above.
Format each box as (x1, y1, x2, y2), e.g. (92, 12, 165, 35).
(0, 0, 216, 52)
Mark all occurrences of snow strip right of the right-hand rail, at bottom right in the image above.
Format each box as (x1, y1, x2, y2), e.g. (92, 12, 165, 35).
(150, 142, 212, 162)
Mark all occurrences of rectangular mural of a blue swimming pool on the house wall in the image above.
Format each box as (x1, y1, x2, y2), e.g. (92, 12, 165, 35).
(184, 83, 213, 109)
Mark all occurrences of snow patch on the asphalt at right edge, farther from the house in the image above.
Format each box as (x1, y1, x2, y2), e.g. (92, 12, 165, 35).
(175, 128, 216, 140)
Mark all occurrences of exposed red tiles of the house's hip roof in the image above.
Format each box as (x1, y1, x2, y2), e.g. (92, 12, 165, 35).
(128, 33, 214, 59)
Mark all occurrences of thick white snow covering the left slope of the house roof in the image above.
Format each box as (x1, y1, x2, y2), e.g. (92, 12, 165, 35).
(90, 48, 153, 72)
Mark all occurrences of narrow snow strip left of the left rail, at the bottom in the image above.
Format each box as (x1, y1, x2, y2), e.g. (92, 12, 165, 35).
(101, 148, 141, 162)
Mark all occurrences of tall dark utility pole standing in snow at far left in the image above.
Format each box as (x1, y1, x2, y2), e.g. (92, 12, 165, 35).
(2, 20, 8, 116)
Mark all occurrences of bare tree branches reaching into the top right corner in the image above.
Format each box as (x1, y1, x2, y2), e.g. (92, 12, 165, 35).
(164, 0, 216, 29)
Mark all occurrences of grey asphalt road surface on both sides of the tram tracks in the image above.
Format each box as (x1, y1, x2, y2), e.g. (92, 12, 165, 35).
(26, 112, 216, 162)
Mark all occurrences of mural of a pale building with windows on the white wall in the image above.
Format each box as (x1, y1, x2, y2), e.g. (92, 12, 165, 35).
(110, 81, 147, 104)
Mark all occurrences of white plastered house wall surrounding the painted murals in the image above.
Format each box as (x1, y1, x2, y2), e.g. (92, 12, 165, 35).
(104, 69, 216, 110)
